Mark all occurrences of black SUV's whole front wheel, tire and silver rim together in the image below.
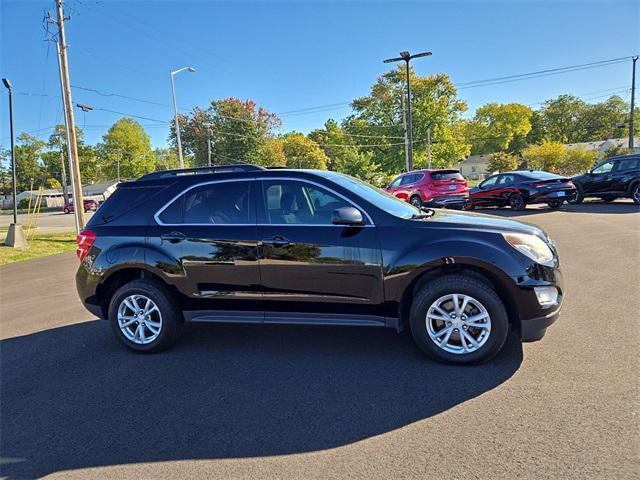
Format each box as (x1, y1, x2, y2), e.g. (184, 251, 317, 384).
(410, 274, 509, 364)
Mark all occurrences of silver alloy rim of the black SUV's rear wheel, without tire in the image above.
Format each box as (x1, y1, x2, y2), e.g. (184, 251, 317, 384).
(118, 294, 162, 345)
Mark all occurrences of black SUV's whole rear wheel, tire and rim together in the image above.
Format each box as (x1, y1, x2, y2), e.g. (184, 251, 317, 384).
(109, 280, 184, 353)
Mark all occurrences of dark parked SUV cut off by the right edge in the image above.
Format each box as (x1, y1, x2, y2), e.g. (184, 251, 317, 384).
(572, 155, 640, 205)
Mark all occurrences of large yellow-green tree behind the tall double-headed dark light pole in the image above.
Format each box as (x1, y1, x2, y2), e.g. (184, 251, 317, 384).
(342, 66, 470, 173)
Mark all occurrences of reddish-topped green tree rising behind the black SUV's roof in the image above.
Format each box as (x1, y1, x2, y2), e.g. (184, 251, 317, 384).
(169, 98, 280, 165)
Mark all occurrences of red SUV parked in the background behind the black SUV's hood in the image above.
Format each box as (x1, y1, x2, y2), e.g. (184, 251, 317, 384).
(385, 170, 469, 208)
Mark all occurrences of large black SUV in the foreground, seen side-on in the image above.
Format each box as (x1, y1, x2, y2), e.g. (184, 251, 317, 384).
(76, 165, 564, 363)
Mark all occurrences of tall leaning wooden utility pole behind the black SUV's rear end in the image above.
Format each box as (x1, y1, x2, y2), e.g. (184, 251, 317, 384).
(56, 0, 85, 230)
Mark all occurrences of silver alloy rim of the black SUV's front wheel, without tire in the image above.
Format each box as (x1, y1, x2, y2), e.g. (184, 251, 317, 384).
(425, 293, 491, 355)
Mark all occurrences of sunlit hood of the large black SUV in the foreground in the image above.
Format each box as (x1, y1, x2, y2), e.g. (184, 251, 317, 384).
(426, 209, 548, 240)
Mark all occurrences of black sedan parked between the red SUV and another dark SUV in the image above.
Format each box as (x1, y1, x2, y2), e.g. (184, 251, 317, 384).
(466, 170, 576, 210)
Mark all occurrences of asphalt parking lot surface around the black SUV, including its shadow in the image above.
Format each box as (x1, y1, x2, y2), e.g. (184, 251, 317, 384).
(0, 202, 640, 479)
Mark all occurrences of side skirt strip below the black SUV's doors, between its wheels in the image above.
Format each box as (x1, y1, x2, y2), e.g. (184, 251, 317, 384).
(184, 310, 398, 330)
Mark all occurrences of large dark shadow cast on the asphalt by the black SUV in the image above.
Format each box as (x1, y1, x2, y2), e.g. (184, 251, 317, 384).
(0, 320, 522, 478)
